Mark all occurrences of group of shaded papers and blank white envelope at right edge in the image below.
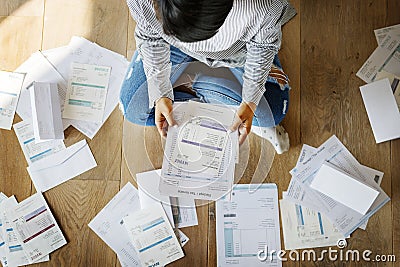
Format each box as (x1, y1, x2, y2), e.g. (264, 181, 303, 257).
(357, 24, 400, 143)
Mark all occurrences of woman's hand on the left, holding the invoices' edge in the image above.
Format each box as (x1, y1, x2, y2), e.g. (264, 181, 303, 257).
(155, 97, 176, 137)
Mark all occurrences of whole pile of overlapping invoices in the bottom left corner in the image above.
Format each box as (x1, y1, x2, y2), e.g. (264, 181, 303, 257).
(0, 193, 67, 266)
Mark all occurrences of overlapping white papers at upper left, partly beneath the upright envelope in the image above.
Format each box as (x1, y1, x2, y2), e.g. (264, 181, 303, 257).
(17, 37, 129, 139)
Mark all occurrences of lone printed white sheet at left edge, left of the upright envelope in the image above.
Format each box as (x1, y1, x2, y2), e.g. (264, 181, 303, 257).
(0, 71, 25, 130)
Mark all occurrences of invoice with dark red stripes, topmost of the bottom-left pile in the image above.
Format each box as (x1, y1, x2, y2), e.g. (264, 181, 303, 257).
(10, 193, 67, 263)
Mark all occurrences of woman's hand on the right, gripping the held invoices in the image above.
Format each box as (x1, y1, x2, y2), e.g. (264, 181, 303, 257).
(230, 102, 257, 145)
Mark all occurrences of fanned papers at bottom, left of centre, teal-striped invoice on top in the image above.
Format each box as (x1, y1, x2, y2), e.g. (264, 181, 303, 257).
(89, 183, 189, 267)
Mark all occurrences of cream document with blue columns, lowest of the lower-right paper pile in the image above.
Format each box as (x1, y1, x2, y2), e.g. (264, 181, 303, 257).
(279, 198, 344, 250)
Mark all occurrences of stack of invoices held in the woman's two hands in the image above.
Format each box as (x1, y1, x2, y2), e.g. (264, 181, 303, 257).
(159, 102, 238, 200)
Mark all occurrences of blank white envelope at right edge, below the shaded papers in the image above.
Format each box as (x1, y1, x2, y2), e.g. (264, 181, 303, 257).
(360, 79, 400, 143)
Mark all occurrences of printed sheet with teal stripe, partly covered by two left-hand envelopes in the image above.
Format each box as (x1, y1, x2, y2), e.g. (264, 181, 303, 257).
(13, 121, 65, 165)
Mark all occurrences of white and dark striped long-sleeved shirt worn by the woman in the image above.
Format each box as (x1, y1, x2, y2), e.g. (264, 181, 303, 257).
(127, 0, 296, 108)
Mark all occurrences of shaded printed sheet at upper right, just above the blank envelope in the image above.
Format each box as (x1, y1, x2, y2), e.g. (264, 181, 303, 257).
(356, 34, 400, 83)
